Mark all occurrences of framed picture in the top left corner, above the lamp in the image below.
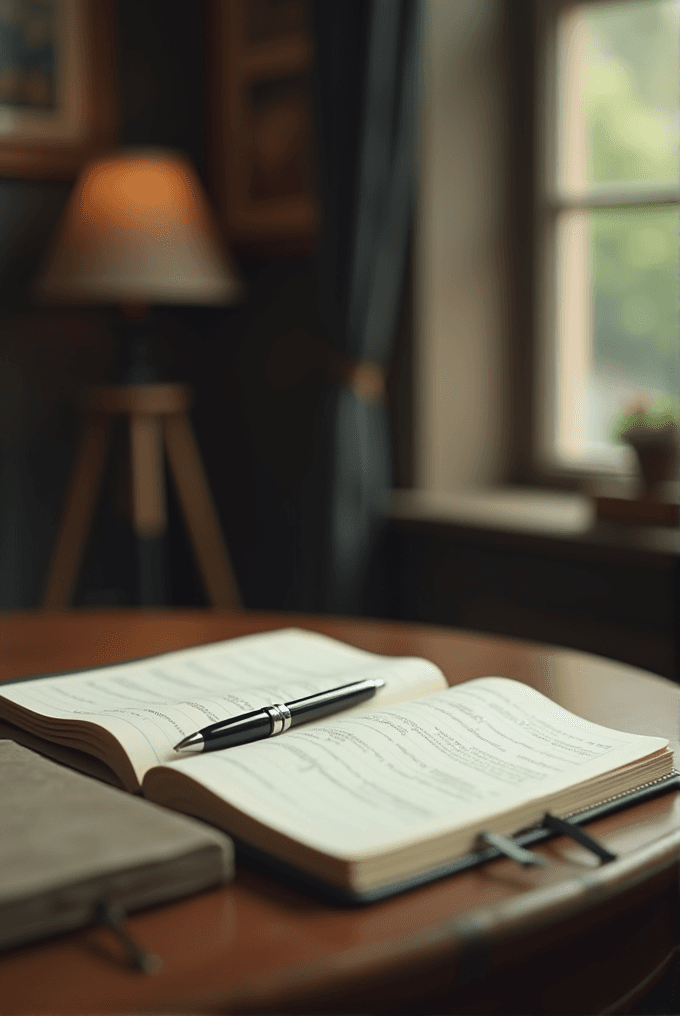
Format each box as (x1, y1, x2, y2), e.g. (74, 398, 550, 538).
(0, 0, 117, 179)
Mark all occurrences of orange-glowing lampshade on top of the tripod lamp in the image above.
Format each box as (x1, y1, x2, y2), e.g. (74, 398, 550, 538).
(37, 149, 242, 304)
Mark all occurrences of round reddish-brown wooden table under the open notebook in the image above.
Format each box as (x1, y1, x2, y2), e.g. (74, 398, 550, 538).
(0, 611, 680, 1014)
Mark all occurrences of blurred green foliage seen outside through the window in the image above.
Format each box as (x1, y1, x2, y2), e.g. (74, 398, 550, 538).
(583, 0, 680, 416)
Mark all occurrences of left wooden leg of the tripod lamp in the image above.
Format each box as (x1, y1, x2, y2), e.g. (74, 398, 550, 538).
(42, 416, 109, 611)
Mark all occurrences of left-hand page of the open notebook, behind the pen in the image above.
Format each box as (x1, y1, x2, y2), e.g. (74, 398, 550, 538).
(0, 629, 446, 780)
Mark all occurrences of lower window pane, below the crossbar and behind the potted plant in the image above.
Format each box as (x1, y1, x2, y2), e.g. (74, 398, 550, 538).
(555, 207, 680, 465)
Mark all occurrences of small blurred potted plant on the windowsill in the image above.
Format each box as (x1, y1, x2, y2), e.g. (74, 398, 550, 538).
(617, 405, 680, 497)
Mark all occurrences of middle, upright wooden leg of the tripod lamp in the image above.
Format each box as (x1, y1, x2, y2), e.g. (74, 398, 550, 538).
(130, 415, 168, 607)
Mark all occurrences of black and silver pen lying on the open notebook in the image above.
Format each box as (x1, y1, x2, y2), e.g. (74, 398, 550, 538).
(175, 678, 384, 752)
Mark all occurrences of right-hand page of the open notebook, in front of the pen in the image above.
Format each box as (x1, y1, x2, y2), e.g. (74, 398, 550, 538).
(157, 678, 667, 859)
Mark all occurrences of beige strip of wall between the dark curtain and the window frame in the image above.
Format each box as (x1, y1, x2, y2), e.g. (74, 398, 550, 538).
(415, 0, 508, 491)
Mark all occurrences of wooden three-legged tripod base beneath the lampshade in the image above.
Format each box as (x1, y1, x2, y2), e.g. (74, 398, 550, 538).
(42, 384, 241, 610)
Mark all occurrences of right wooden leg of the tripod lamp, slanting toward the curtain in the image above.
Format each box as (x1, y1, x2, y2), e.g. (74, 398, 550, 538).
(165, 412, 241, 610)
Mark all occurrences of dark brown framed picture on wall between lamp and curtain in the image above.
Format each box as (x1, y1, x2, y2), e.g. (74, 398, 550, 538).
(206, 0, 319, 256)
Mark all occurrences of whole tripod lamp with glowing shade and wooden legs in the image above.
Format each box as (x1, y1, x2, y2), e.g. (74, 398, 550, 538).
(36, 148, 243, 609)
